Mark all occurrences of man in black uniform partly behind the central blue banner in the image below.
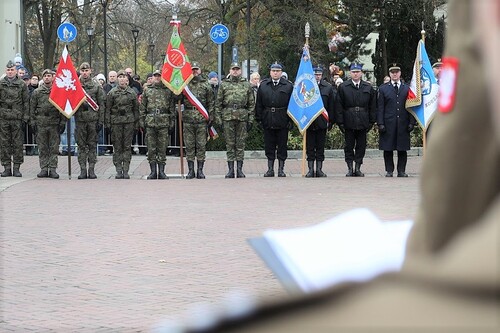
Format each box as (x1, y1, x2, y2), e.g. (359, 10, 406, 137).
(306, 67, 335, 178)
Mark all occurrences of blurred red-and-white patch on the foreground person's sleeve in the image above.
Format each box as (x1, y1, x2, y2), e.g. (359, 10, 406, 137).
(439, 57, 459, 113)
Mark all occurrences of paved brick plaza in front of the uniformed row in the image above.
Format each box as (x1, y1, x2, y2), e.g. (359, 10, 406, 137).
(0, 152, 422, 332)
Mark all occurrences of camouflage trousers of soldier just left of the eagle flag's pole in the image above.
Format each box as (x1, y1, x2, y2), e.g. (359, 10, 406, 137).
(36, 125, 61, 170)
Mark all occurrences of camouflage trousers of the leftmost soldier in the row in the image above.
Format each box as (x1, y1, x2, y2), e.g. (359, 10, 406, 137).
(0, 119, 24, 166)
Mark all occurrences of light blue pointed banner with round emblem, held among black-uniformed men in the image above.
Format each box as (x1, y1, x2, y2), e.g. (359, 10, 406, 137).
(288, 45, 326, 134)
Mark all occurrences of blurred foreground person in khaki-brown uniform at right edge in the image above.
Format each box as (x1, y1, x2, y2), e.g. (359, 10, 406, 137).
(173, 0, 500, 333)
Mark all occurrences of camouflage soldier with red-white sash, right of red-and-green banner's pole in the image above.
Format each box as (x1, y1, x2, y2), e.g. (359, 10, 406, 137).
(182, 62, 214, 179)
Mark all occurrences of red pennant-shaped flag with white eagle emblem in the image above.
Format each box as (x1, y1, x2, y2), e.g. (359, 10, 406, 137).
(49, 46, 86, 119)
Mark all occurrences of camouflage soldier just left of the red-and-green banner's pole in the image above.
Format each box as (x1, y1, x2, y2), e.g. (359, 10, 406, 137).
(140, 70, 175, 179)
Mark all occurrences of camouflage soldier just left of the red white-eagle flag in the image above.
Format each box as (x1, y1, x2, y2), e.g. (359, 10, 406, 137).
(30, 69, 66, 179)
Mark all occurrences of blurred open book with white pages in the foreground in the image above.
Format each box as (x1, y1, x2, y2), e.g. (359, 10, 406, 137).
(249, 208, 413, 293)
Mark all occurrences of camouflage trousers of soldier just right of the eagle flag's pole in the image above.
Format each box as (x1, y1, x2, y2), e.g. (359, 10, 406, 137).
(75, 121, 97, 166)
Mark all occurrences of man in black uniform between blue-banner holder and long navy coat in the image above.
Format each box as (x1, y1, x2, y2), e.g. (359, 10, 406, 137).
(335, 63, 377, 177)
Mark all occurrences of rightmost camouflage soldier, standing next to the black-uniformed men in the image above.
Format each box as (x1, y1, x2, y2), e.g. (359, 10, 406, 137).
(215, 63, 255, 178)
